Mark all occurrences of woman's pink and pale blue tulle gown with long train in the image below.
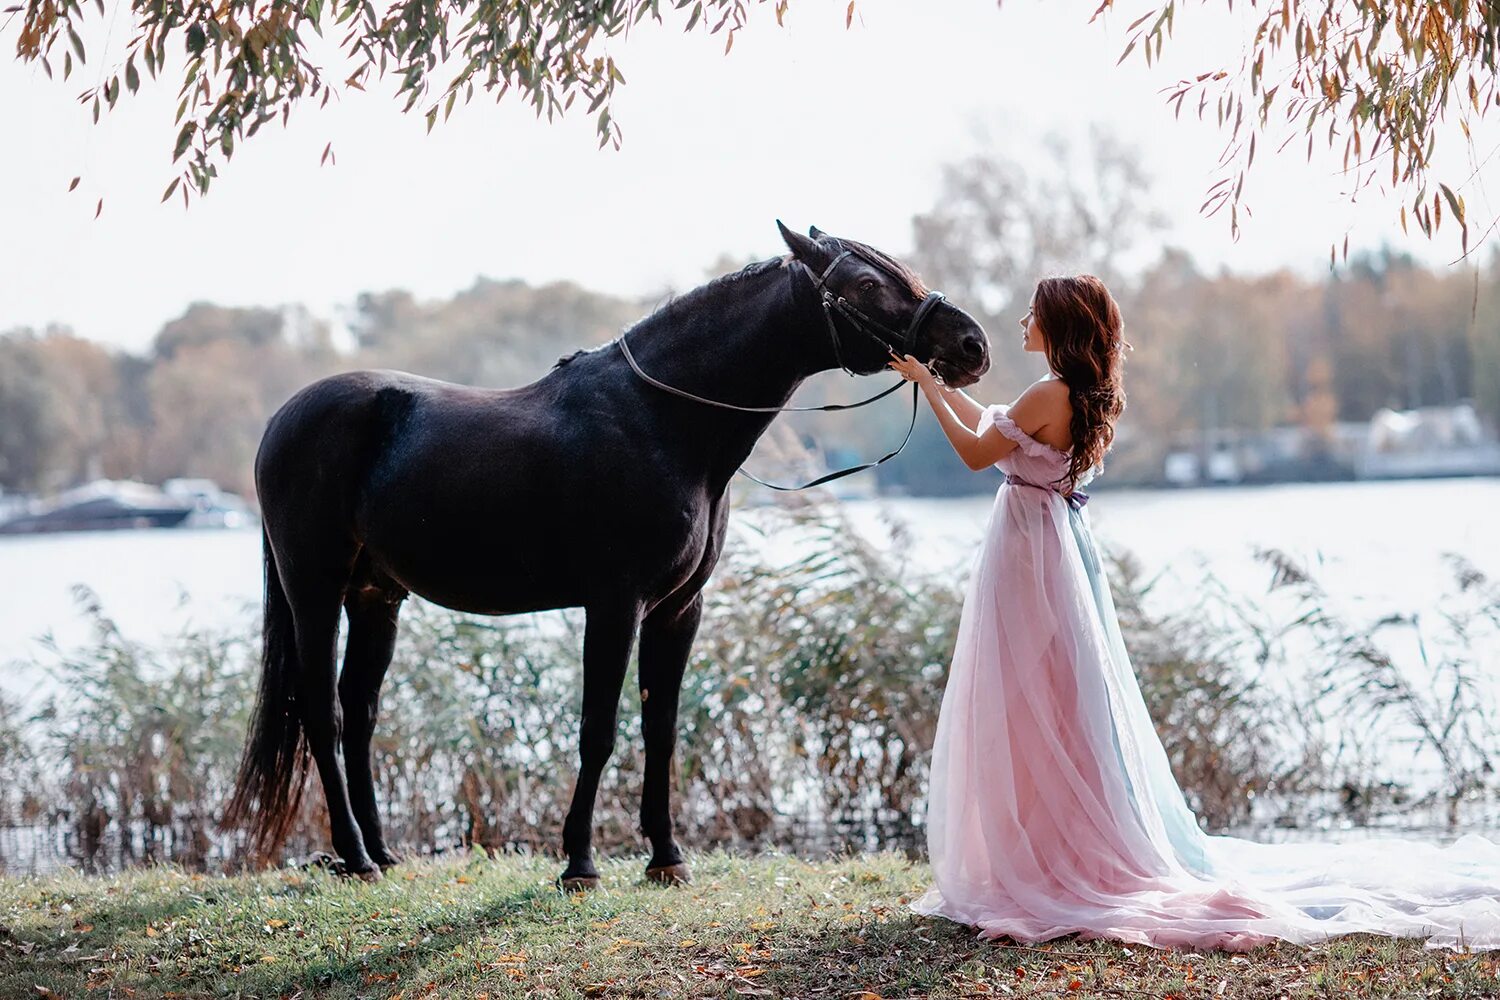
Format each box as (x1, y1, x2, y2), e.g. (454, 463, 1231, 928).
(911, 406, 1500, 951)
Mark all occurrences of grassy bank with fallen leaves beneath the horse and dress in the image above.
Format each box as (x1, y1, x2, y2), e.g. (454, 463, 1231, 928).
(0, 853, 1500, 1000)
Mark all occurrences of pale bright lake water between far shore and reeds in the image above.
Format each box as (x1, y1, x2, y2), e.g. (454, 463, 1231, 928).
(0, 480, 1500, 697)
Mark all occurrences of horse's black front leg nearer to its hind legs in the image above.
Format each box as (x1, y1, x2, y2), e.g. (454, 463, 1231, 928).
(558, 601, 641, 891)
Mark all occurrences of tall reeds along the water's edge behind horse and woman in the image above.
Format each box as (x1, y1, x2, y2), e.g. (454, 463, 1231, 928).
(0, 502, 1500, 868)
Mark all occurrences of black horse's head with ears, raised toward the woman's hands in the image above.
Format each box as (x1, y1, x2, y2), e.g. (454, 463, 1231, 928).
(776, 219, 990, 387)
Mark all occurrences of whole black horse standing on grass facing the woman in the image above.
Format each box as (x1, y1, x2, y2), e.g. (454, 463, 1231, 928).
(224, 222, 990, 889)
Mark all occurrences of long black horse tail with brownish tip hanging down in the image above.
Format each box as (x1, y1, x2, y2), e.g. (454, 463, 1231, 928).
(221, 528, 309, 858)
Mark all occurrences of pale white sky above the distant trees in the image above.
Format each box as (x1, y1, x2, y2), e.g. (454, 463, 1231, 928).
(0, 0, 1484, 349)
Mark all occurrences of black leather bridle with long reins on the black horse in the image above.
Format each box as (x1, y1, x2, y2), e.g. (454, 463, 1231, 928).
(617, 250, 944, 492)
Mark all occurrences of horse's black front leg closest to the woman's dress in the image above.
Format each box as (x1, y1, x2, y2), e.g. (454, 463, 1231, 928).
(639, 592, 704, 885)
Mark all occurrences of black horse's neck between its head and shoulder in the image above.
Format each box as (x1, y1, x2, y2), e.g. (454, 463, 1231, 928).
(626, 265, 834, 481)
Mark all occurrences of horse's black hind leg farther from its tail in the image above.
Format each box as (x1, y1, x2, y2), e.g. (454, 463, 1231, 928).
(339, 558, 407, 868)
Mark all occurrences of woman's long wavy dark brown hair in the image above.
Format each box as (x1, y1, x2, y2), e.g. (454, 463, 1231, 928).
(1032, 274, 1128, 493)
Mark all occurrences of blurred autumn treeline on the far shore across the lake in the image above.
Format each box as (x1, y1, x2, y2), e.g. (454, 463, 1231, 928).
(0, 133, 1500, 499)
